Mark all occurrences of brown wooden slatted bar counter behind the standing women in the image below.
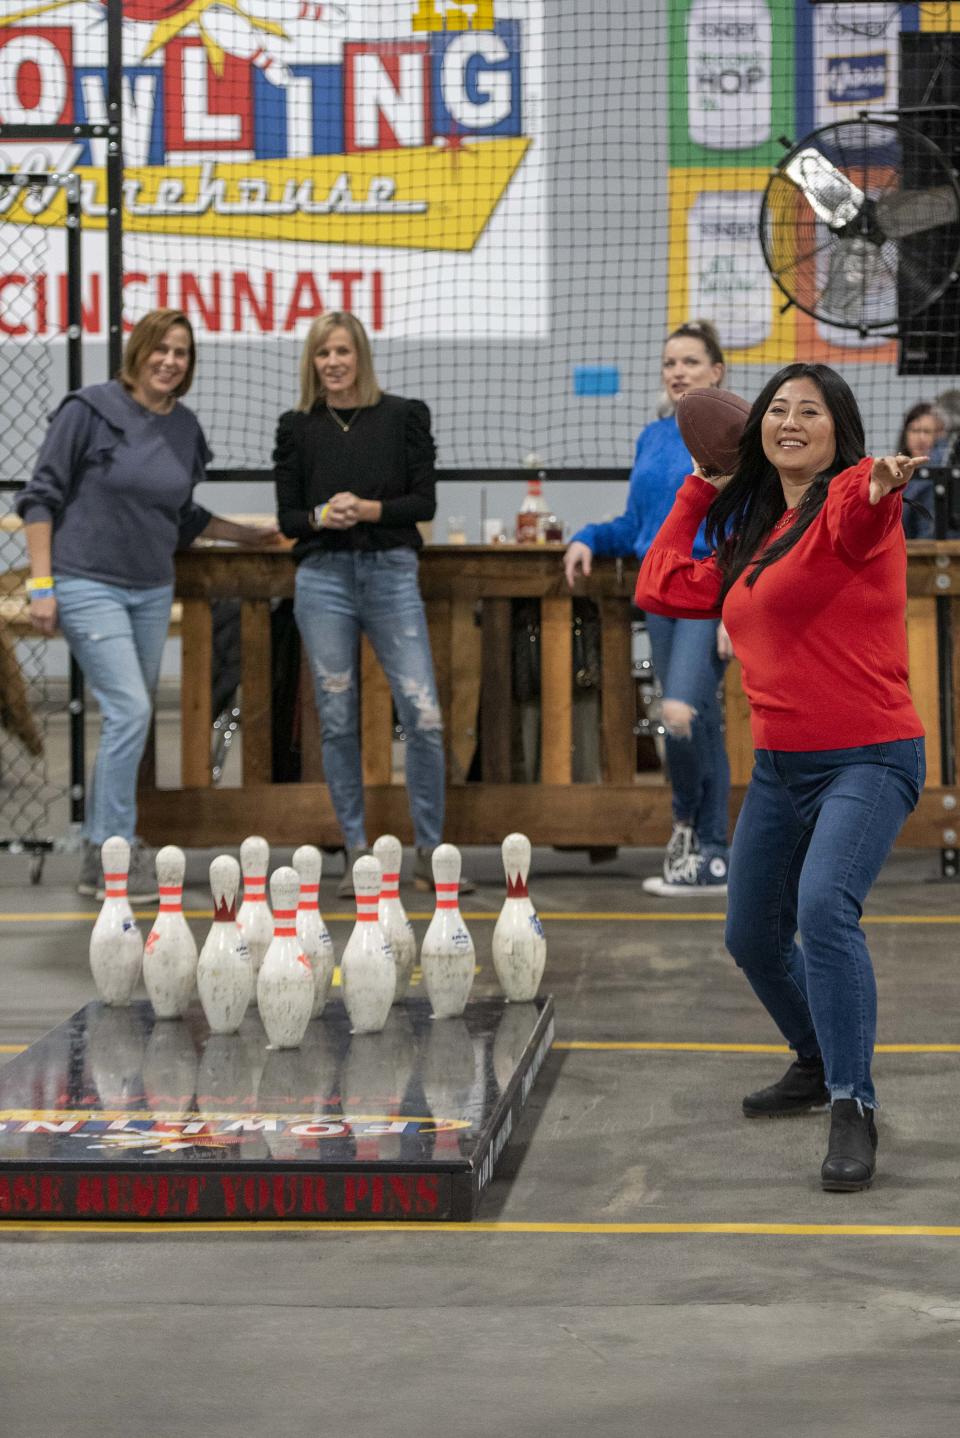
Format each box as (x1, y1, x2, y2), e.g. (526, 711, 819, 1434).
(139, 541, 960, 848)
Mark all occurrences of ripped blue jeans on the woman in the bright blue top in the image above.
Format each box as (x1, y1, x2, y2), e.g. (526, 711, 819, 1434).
(647, 614, 730, 858)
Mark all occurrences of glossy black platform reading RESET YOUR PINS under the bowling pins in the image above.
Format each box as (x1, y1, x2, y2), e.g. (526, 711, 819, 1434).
(0, 997, 553, 1221)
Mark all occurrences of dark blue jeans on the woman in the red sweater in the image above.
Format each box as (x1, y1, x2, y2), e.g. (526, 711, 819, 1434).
(726, 739, 926, 1109)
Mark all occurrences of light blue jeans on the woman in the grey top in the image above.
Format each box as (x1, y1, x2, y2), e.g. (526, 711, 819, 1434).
(56, 575, 174, 844)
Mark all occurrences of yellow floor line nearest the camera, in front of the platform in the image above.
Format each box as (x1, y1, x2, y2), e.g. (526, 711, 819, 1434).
(0, 1218, 960, 1238)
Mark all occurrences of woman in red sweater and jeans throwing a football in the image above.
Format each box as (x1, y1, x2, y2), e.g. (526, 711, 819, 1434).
(637, 364, 926, 1191)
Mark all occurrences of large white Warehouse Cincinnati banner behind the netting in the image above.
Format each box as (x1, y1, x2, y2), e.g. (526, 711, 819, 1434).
(0, 0, 548, 339)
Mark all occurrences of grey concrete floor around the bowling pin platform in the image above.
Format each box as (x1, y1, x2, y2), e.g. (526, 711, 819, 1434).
(0, 850, 960, 1438)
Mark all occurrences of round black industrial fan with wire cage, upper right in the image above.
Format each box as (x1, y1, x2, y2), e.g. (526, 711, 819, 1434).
(760, 118, 960, 335)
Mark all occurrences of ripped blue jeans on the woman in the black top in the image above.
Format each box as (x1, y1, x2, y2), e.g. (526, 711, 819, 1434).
(293, 548, 444, 848)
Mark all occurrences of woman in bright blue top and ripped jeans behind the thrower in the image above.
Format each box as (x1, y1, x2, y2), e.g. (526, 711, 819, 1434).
(563, 321, 730, 894)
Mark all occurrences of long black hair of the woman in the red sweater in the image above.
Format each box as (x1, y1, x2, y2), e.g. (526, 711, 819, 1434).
(706, 364, 865, 598)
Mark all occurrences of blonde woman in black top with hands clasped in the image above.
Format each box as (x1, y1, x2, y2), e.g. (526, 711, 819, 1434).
(273, 312, 444, 897)
